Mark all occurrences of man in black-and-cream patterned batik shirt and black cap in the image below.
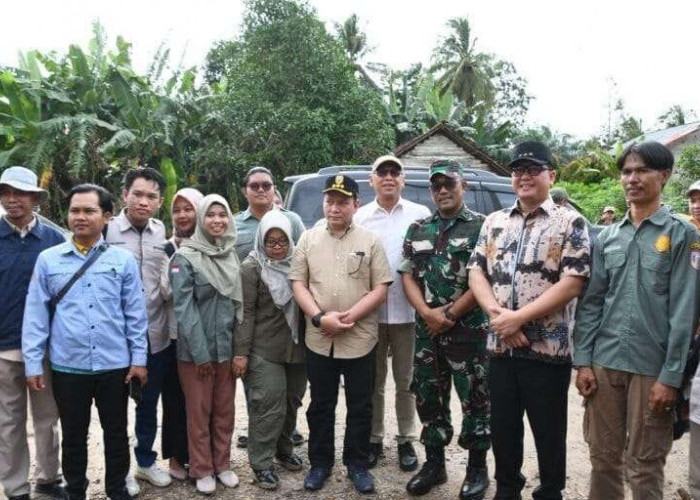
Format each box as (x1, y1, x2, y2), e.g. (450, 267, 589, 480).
(469, 141, 590, 499)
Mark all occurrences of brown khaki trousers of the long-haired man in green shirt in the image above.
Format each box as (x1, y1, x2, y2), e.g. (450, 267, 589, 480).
(583, 366, 673, 500)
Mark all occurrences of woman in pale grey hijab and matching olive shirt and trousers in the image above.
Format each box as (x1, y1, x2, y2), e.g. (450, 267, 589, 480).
(234, 210, 306, 489)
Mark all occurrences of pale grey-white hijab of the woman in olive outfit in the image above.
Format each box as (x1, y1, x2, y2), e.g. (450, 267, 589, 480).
(249, 209, 299, 344)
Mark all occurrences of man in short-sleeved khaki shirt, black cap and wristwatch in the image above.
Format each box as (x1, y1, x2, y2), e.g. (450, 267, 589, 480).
(289, 175, 393, 493)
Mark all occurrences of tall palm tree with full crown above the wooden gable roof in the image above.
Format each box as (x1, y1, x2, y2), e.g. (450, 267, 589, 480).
(431, 17, 496, 108)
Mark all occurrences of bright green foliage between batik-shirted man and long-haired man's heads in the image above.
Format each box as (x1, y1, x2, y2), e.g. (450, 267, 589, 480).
(555, 178, 627, 223)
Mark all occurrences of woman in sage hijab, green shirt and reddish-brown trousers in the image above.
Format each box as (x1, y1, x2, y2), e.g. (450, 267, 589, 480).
(170, 194, 243, 494)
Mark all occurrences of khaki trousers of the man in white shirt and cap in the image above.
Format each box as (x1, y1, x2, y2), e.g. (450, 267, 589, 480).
(370, 323, 416, 444)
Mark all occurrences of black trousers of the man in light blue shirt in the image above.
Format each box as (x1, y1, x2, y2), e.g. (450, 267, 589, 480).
(52, 368, 129, 500)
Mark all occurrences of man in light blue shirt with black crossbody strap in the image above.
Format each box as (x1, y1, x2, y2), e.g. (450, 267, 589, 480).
(22, 184, 148, 500)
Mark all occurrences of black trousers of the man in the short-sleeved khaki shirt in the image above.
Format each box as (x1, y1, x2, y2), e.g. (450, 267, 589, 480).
(306, 347, 376, 468)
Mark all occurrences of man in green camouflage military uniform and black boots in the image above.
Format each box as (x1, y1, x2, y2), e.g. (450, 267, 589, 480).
(399, 160, 490, 500)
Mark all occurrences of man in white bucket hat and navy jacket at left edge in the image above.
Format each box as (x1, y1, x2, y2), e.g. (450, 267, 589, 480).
(0, 167, 65, 500)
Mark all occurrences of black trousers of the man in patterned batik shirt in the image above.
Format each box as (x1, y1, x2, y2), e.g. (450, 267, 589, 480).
(489, 357, 571, 500)
